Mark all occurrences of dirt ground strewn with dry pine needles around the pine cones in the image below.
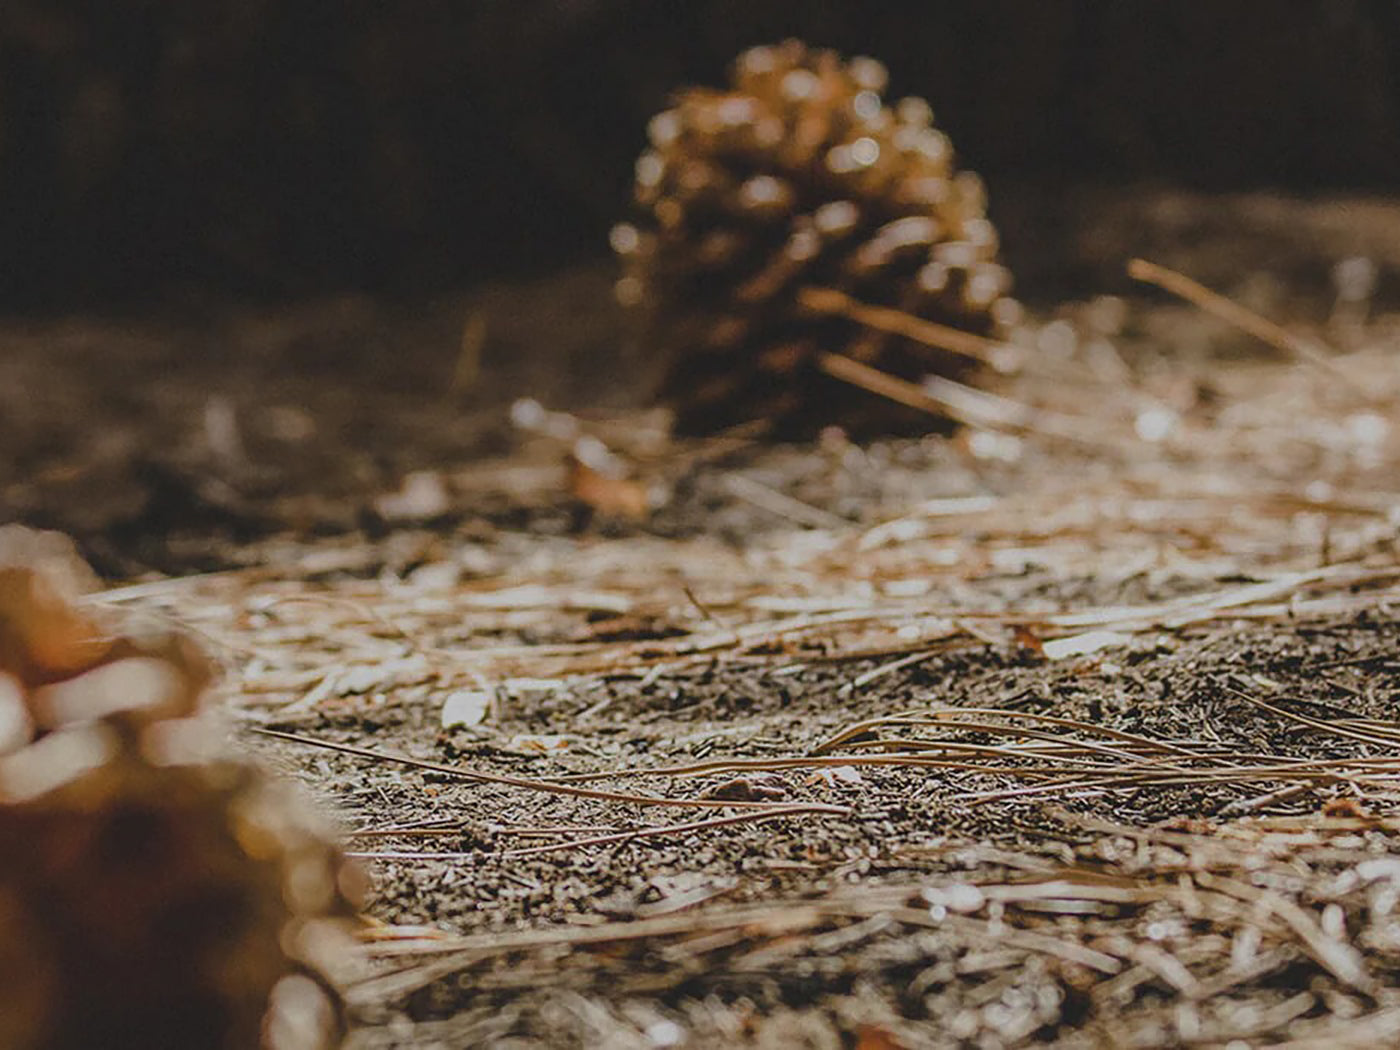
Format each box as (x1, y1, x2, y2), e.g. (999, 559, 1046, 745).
(8, 199, 1400, 1050)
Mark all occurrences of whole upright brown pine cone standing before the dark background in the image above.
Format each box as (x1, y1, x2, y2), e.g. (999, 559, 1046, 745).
(612, 41, 1019, 434)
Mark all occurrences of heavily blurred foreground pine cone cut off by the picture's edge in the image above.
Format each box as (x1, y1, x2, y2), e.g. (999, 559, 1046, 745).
(0, 528, 358, 1050)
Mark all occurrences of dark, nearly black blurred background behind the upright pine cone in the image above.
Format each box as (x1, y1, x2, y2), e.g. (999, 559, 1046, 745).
(0, 0, 1400, 309)
